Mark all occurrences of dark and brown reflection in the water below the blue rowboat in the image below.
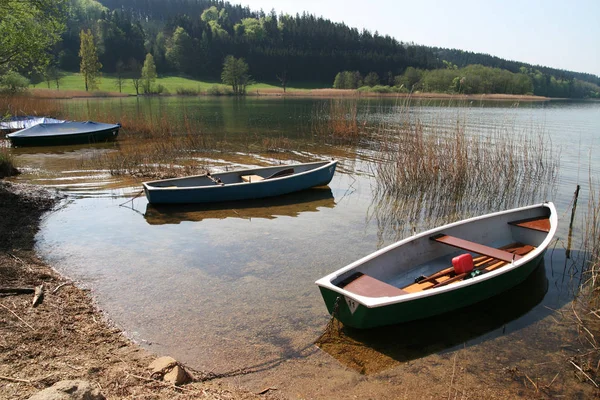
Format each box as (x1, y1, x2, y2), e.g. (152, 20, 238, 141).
(144, 186, 335, 225)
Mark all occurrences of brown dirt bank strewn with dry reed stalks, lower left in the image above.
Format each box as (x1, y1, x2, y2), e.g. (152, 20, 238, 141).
(0, 181, 277, 399)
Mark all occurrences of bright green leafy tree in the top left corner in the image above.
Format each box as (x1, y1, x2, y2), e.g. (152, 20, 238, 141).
(0, 0, 67, 70)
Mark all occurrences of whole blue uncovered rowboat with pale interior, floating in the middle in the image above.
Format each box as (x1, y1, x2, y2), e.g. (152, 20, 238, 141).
(143, 161, 337, 204)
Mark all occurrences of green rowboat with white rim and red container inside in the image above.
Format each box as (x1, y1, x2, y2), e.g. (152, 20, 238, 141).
(316, 203, 558, 328)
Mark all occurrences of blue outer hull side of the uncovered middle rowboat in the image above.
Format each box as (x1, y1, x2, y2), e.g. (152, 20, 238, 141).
(144, 162, 336, 204)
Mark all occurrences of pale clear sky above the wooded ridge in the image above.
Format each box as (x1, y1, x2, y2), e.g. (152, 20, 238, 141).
(229, 0, 600, 76)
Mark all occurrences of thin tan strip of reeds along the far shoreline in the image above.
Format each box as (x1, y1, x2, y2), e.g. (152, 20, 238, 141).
(29, 88, 552, 101)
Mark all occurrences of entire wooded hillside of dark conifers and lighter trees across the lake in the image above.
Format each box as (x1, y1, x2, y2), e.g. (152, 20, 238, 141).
(8, 0, 600, 98)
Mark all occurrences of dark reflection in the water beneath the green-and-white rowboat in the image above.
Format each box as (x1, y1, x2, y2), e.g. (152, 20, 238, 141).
(316, 262, 548, 374)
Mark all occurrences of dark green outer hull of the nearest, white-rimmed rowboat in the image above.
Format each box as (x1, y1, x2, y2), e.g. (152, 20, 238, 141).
(319, 254, 543, 329)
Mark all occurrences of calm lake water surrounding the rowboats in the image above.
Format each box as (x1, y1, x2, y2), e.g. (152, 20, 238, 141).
(5, 98, 600, 396)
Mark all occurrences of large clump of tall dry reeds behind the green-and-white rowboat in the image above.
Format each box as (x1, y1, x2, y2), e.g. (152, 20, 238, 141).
(369, 101, 560, 243)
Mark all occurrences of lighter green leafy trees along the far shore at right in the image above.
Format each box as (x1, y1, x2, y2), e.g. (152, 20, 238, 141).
(333, 62, 600, 98)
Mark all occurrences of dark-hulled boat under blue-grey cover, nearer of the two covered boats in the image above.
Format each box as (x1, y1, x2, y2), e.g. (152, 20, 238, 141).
(6, 121, 121, 146)
